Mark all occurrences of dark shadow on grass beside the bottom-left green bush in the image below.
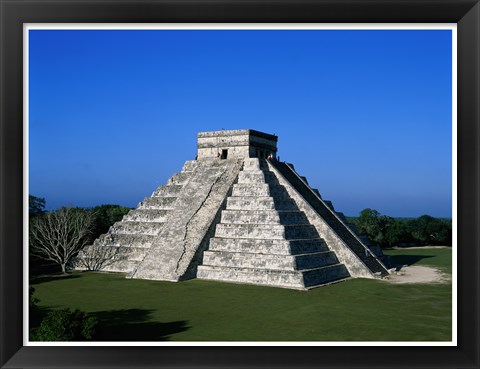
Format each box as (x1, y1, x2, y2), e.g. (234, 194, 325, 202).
(90, 309, 190, 342)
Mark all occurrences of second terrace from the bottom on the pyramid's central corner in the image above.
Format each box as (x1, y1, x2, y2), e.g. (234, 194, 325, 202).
(203, 251, 338, 270)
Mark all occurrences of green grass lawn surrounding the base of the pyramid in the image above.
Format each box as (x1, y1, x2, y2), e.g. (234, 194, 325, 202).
(31, 248, 452, 341)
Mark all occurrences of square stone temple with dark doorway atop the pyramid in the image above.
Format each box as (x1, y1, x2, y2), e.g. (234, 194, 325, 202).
(197, 129, 278, 159)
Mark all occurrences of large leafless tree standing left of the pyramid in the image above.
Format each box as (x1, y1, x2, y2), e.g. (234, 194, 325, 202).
(29, 208, 93, 273)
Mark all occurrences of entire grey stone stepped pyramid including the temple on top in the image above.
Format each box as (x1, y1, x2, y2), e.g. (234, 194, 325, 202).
(77, 129, 388, 289)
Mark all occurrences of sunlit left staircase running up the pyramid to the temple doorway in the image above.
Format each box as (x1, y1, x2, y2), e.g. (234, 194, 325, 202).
(128, 159, 242, 281)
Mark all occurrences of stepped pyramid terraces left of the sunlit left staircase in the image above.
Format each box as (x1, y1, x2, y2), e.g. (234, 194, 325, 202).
(76, 161, 197, 273)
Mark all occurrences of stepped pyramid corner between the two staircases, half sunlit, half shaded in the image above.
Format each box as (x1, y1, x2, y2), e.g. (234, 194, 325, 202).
(197, 158, 349, 289)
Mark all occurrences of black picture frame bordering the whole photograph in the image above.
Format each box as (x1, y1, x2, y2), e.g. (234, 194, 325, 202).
(0, 0, 480, 369)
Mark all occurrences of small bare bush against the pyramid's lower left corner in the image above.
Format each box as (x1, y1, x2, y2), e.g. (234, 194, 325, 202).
(75, 241, 130, 270)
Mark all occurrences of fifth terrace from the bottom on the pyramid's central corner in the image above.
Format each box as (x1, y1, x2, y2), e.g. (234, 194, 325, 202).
(221, 210, 308, 224)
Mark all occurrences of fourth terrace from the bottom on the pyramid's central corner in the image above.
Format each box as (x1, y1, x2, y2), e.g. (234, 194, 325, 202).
(215, 224, 318, 240)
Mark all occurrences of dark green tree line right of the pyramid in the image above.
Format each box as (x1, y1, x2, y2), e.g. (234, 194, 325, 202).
(349, 208, 452, 248)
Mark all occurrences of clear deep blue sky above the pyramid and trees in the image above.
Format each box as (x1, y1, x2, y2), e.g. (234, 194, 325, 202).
(29, 30, 452, 217)
